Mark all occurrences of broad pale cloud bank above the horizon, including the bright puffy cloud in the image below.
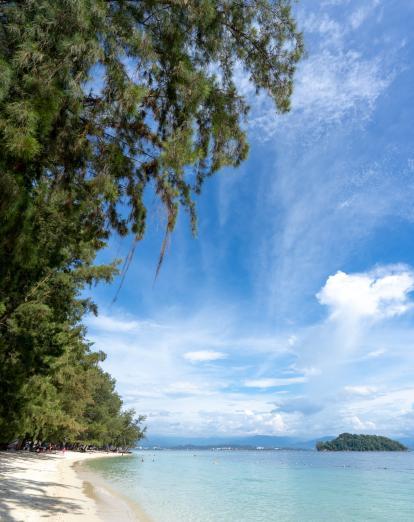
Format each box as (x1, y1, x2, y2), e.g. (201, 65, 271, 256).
(89, 266, 414, 436)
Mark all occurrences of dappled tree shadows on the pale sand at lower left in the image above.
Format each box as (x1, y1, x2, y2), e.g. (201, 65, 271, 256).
(0, 453, 82, 522)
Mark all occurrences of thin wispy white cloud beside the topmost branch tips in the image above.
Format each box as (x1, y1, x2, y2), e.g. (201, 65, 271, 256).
(246, 0, 398, 141)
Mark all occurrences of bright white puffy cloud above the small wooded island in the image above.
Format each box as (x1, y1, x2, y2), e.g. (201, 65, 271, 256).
(316, 267, 414, 319)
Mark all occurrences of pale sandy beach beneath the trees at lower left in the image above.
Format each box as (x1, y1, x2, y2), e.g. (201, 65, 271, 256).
(0, 451, 149, 522)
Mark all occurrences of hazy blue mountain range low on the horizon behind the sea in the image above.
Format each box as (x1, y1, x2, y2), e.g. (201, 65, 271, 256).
(139, 435, 414, 450)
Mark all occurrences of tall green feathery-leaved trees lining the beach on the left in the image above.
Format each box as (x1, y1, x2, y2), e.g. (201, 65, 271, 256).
(0, 0, 303, 445)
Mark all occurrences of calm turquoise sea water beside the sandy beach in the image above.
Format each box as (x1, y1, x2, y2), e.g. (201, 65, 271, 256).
(88, 451, 414, 522)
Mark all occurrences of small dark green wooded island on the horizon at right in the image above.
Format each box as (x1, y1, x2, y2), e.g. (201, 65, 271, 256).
(316, 433, 408, 451)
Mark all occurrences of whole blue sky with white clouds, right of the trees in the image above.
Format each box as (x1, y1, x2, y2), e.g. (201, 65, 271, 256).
(87, 0, 414, 438)
